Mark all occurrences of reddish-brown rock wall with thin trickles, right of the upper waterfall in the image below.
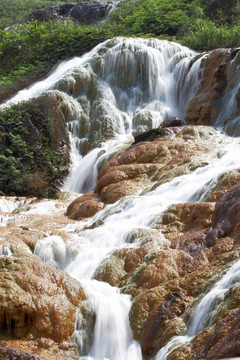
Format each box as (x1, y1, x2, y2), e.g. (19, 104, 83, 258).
(185, 49, 240, 132)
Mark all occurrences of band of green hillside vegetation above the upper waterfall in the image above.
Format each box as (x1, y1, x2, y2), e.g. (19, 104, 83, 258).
(0, 0, 240, 96)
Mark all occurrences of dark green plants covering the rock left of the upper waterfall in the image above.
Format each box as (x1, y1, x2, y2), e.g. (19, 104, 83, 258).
(0, 103, 61, 195)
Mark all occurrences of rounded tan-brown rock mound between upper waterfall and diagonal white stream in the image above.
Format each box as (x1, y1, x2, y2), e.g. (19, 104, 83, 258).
(67, 126, 227, 214)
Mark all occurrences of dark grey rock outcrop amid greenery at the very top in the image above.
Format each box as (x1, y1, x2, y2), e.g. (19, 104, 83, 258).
(26, 1, 113, 25)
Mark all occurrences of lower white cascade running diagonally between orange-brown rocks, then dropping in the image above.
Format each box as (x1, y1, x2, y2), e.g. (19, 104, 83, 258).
(32, 135, 240, 360)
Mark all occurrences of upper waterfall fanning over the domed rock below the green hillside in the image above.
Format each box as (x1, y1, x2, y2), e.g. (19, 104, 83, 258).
(2, 38, 201, 193)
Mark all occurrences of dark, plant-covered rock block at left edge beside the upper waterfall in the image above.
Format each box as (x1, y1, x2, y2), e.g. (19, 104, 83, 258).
(0, 93, 70, 197)
